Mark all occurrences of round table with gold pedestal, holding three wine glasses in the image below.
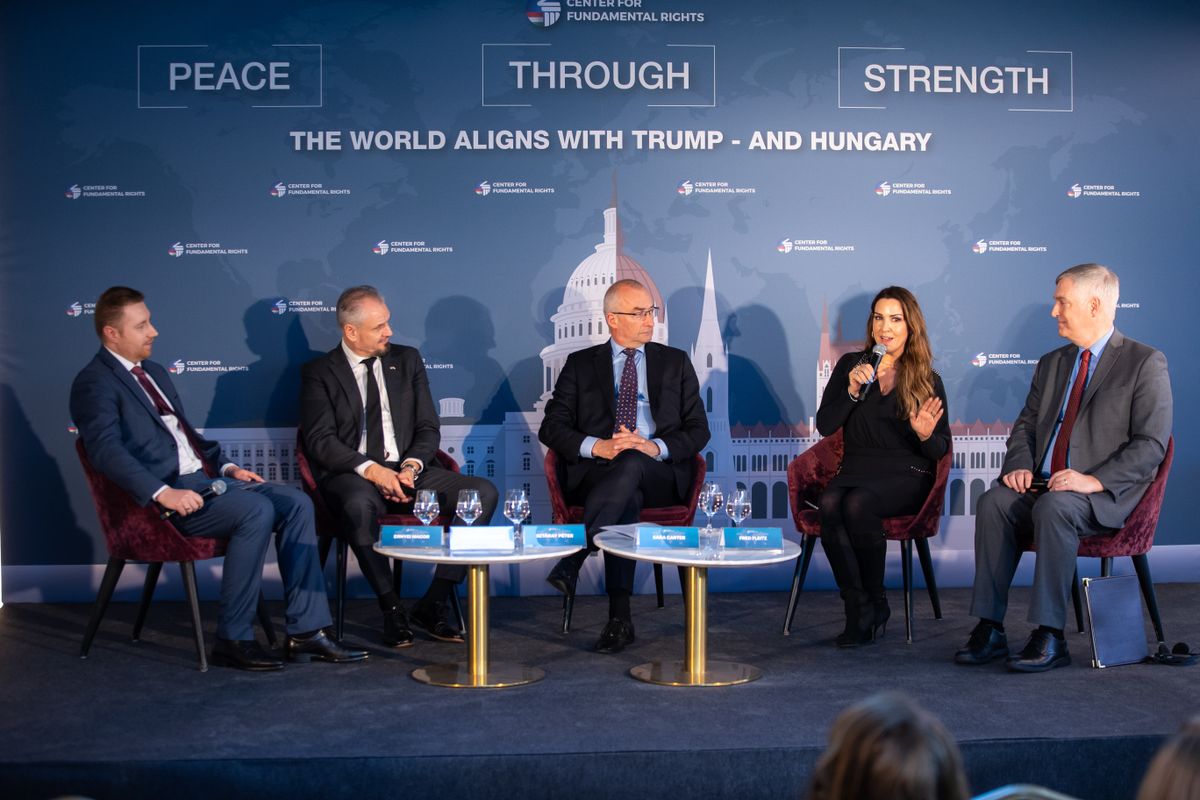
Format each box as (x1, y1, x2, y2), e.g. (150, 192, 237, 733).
(374, 545, 580, 688)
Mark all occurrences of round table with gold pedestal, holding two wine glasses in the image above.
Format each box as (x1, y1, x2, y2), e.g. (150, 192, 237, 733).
(595, 533, 800, 686)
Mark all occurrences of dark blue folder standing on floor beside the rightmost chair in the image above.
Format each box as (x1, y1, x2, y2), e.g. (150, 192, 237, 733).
(1084, 575, 1146, 669)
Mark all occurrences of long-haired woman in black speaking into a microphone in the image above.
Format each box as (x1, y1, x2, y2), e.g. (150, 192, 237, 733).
(816, 287, 950, 648)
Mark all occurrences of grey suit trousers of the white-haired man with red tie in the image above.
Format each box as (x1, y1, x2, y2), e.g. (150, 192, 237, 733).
(971, 485, 1112, 630)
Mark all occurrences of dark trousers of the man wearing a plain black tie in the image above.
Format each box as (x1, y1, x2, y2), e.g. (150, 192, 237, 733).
(319, 464, 499, 597)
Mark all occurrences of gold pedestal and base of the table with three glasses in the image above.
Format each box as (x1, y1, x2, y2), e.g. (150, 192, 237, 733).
(413, 564, 546, 688)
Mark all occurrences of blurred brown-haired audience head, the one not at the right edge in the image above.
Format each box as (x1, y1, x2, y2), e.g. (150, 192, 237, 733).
(809, 692, 968, 800)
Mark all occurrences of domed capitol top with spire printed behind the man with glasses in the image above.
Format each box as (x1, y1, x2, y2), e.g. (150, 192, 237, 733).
(535, 190, 667, 410)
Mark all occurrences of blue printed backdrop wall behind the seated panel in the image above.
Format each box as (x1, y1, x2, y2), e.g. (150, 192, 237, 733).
(0, 0, 1200, 599)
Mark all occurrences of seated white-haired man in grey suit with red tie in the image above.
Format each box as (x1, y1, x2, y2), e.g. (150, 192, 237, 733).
(954, 264, 1171, 672)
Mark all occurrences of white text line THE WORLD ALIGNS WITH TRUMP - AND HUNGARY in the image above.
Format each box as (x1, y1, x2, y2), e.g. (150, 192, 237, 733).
(288, 130, 934, 152)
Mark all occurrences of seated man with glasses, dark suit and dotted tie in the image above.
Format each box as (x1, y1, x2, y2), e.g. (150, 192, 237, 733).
(538, 279, 709, 652)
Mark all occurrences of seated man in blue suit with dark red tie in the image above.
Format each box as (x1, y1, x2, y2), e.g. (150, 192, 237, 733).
(71, 287, 367, 670)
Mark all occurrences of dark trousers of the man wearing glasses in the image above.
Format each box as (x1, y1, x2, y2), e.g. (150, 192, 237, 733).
(566, 450, 683, 595)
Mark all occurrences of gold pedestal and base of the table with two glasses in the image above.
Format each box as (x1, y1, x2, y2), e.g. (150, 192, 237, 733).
(629, 566, 762, 686)
